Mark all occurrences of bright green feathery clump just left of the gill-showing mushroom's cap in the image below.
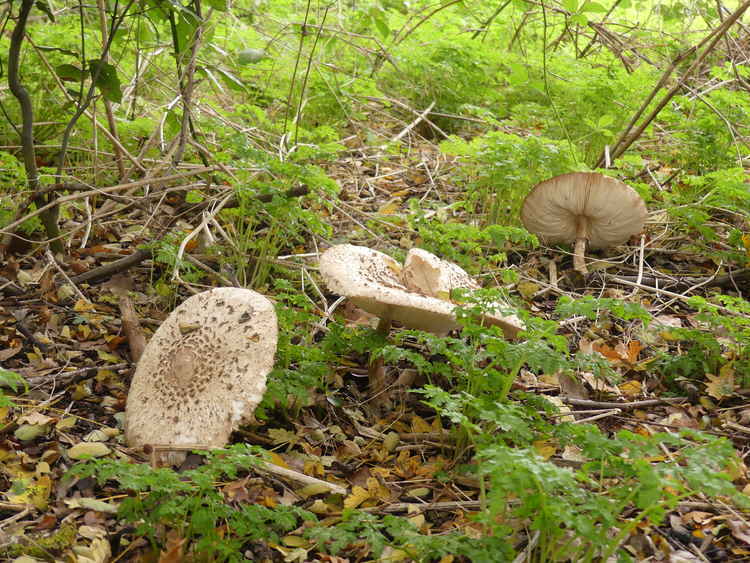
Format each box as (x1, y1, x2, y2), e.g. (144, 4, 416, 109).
(441, 131, 576, 225)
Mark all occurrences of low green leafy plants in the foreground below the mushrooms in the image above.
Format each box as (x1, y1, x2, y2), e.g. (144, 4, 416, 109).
(66, 294, 750, 563)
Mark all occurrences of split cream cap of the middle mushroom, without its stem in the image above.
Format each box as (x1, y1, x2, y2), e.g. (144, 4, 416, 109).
(320, 244, 523, 337)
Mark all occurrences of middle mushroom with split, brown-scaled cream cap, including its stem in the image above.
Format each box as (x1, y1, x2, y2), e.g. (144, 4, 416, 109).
(320, 244, 524, 400)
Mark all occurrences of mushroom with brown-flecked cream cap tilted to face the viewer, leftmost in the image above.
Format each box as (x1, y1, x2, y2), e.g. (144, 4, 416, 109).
(125, 287, 277, 464)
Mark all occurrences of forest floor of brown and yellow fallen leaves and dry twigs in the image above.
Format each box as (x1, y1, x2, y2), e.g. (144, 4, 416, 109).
(0, 15, 750, 563)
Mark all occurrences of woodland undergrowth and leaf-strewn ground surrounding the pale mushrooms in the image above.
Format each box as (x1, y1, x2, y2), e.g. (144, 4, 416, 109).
(0, 0, 750, 563)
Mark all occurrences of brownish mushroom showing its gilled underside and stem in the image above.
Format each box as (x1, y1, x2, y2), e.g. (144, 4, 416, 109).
(521, 172, 646, 275)
